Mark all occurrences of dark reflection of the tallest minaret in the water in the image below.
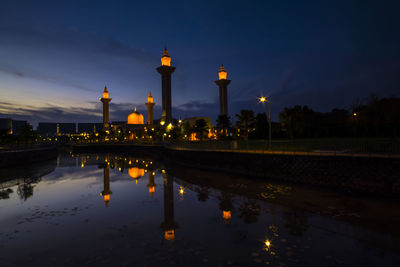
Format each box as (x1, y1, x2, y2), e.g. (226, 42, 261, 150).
(161, 172, 178, 240)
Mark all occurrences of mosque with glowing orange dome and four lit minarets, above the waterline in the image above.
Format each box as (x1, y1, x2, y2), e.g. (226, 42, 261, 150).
(100, 48, 231, 140)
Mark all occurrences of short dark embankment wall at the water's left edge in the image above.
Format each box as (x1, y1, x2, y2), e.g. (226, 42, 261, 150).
(0, 146, 57, 168)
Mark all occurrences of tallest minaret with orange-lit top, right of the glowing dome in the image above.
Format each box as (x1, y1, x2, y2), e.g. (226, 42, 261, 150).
(157, 48, 175, 125)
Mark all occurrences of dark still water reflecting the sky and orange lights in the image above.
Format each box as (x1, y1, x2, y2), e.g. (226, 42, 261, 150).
(0, 154, 400, 267)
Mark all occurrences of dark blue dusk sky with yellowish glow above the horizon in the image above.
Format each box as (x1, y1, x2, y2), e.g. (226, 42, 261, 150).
(0, 0, 400, 125)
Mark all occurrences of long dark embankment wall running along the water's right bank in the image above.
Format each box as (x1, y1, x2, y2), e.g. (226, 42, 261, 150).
(73, 145, 400, 197)
